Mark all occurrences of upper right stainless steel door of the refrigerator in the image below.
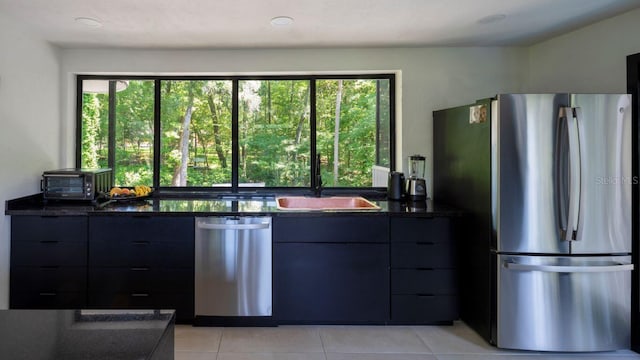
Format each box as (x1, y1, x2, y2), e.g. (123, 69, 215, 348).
(571, 94, 633, 254)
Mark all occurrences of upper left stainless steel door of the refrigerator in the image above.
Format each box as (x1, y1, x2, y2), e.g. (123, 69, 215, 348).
(491, 94, 569, 254)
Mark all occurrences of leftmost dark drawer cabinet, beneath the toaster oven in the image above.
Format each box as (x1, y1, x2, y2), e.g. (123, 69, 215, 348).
(9, 216, 87, 309)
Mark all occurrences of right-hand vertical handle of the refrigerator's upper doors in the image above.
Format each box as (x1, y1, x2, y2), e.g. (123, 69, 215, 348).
(560, 107, 582, 241)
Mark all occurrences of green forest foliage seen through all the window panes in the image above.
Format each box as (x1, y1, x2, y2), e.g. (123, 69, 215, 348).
(81, 79, 389, 187)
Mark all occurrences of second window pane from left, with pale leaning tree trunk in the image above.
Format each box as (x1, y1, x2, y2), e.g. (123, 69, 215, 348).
(160, 80, 232, 187)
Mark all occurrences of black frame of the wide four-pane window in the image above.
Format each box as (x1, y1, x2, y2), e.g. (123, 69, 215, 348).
(75, 73, 397, 193)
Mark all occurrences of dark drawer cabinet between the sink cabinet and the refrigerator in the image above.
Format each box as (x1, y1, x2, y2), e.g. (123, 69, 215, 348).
(390, 216, 458, 324)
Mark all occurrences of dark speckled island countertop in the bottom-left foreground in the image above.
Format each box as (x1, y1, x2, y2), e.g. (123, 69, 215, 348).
(0, 310, 174, 360)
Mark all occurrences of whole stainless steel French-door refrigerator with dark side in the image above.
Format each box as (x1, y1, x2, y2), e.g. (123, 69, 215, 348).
(433, 94, 633, 351)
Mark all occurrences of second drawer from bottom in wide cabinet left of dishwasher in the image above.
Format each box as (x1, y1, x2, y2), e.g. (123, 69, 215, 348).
(89, 268, 194, 293)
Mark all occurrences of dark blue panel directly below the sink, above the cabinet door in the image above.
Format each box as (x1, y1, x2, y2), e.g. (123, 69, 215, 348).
(273, 216, 389, 243)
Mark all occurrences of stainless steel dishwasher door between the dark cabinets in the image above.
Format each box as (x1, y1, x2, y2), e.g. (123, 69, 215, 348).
(195, 217, 272, 316)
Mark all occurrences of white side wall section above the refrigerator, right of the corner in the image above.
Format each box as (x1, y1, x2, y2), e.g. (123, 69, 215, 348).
(526, 9, 640, 93)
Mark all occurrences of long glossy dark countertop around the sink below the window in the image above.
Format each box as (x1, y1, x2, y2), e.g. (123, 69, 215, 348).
(5, 194, 461, 217)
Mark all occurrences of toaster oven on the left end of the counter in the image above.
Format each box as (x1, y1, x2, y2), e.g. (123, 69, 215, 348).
(40, 168, 113, 200)
